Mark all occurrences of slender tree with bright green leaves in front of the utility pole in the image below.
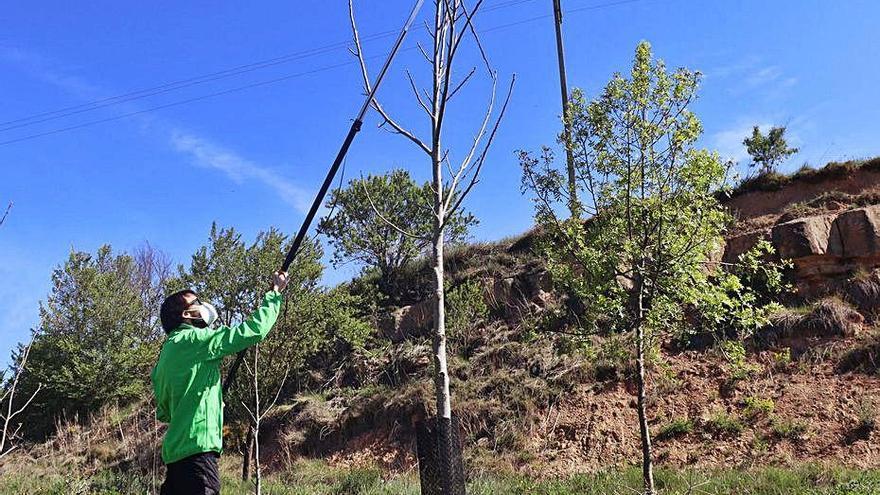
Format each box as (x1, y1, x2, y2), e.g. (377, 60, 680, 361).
(520, 42, 780, 494)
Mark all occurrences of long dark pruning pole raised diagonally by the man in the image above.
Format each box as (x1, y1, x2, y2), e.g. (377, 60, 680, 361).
(223, 0, 424, 394)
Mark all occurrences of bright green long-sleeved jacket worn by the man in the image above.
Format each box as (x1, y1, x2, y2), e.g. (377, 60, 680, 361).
(150, 290, 281, 464)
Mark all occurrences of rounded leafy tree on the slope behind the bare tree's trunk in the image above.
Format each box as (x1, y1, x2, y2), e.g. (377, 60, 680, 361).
(318, 169, 477, 295)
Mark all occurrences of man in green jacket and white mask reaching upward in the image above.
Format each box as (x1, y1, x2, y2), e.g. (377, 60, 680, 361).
(150, 272, 288, 495)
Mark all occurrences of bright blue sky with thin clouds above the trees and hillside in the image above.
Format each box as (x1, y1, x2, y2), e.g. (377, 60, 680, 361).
(0, 0, 880, 359)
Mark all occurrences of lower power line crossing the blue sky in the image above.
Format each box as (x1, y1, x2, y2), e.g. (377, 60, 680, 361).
(0, 0, 643, 146)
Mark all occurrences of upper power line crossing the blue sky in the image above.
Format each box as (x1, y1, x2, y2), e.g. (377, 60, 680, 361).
(0, 0, 535, 132)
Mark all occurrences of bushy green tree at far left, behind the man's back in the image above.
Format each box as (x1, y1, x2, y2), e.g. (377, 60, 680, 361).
(13, 245, 167, 438)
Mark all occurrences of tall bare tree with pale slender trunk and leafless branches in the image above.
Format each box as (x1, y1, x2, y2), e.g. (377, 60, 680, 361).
(348, 0, 516, 493)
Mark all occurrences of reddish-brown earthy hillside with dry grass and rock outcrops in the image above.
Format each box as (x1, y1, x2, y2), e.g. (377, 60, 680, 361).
(0, 159, 880, 493)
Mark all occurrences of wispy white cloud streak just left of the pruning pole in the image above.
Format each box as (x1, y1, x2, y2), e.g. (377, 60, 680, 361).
(171, 130, 309, 213)
